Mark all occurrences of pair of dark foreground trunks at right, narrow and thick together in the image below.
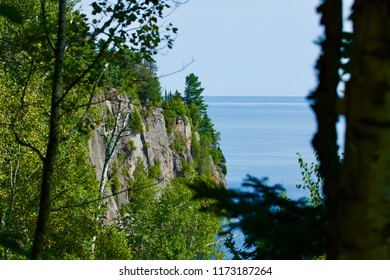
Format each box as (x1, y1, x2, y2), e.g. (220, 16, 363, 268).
(311, 0, 390, 259)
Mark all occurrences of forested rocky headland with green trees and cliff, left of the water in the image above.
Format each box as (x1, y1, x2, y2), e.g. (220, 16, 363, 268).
(0, 0, 226, 259)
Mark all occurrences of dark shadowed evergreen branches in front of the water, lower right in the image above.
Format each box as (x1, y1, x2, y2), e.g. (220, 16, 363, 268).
(193, 175, 326, 259)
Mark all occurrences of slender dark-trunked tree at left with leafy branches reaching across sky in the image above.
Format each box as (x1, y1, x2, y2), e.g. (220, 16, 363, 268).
(1, 0, 181, 259)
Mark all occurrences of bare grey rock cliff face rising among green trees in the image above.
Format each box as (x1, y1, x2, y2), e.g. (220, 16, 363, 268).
(90, 101, 226, 219)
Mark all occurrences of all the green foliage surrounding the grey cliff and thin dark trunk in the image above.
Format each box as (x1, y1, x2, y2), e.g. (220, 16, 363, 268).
(0, 0, 220, 259)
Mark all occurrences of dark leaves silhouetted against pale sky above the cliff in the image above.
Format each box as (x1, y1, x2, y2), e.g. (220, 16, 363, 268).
(87, 0, 177, 59)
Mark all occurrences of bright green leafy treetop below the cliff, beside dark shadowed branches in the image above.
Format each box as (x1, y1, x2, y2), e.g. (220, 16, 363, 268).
(122, 176, 221, 260)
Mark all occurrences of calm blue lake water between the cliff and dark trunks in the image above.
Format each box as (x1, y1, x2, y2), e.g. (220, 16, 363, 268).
(205, 97, 315, 198)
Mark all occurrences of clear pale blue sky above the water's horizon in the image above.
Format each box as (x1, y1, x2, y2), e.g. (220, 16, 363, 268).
(156, 0, 352, 96)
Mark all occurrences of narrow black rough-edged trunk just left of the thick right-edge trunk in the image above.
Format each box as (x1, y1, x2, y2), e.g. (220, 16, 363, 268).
(309, 0, 342, 259)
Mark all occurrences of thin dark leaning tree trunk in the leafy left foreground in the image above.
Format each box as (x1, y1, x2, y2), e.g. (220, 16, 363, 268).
(31, 0, 66, 259)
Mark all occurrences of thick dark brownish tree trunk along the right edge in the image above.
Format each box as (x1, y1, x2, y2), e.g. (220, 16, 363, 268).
(339, 0, 390, 259)
